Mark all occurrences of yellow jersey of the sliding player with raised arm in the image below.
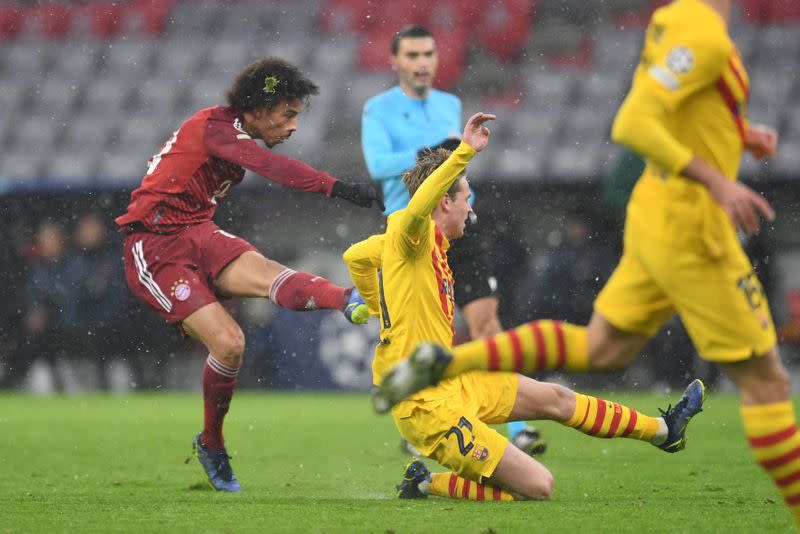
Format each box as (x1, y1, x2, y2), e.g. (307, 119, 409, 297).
(343, 143, 476, 385)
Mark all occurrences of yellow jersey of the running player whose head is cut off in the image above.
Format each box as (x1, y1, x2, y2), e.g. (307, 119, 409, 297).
(612, 0, 750, 257)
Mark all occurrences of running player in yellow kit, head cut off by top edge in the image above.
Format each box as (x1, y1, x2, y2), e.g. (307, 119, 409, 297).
(376, 0, 800, 524)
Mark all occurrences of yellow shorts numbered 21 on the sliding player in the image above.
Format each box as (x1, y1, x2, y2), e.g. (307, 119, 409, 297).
(392, 371, 519, 482)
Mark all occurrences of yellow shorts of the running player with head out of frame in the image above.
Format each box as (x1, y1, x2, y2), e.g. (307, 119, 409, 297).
(594, 218, 776, 362)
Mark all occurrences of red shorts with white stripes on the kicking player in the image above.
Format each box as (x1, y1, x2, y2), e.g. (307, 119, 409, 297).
(124, 222, 257, 323)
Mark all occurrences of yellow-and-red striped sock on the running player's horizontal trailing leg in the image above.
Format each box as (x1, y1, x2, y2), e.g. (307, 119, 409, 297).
(444, 321, 589, 378)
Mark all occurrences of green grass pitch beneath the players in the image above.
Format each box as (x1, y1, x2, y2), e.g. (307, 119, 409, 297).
(0, 392, 792, 534)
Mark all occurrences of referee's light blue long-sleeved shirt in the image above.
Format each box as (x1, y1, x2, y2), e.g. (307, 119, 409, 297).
(361, 85, 461, 215)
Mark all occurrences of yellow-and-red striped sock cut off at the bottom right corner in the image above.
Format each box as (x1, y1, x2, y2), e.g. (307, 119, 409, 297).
(741, 401, 800, 527)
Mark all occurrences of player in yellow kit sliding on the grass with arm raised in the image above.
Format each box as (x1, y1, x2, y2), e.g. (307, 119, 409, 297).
(344, 113, 703, 500)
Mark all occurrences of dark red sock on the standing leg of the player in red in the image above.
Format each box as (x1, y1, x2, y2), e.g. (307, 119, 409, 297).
(200, 354, 239, 451)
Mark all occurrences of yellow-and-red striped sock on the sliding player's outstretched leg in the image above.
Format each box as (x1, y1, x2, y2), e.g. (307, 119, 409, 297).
(563, 393, 659, 441)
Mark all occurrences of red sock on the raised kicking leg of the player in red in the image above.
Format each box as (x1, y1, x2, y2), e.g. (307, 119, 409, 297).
(269, 269, 347, 311)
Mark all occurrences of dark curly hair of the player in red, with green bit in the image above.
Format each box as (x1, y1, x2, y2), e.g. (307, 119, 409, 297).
(227, 57, 319, 112)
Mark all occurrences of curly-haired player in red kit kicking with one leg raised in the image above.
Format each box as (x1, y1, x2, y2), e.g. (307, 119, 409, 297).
(116, 57, 383, 491)
